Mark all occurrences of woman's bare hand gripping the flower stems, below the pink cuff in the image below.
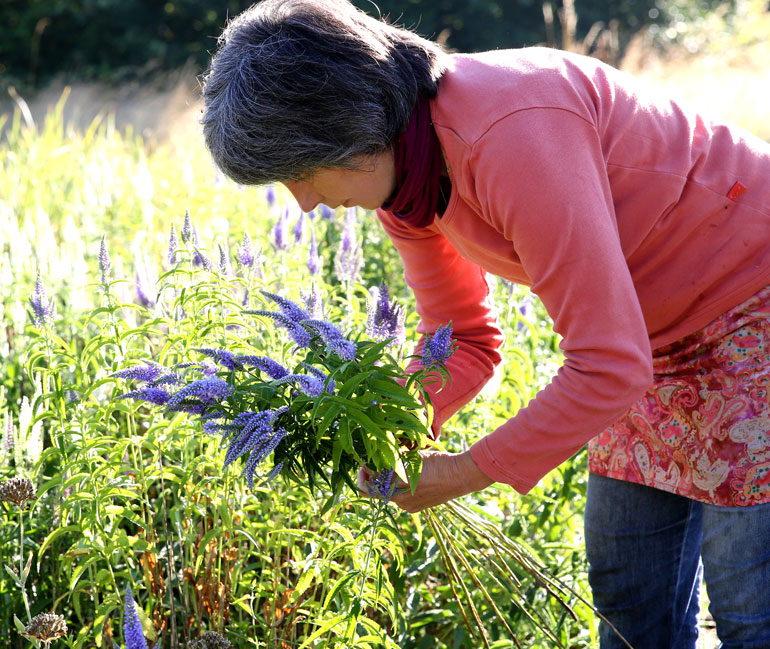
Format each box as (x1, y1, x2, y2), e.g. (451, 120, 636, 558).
(358, 451, 494, 513)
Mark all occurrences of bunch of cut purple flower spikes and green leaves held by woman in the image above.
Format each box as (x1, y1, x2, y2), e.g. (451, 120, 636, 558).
(113, 286, 440, 499)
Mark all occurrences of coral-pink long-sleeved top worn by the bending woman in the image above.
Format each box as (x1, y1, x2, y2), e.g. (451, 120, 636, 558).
(378, 48, 770, 493)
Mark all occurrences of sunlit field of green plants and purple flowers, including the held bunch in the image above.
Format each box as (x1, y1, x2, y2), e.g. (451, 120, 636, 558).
(0, 97, 597, 649)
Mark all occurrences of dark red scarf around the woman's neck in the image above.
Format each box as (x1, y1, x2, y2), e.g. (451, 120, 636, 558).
(382, 97, 442, 228)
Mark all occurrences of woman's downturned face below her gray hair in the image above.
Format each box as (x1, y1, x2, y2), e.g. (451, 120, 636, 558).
(284, 150, 396, 212)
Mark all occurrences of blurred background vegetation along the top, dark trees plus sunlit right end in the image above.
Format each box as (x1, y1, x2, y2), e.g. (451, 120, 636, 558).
(0, 0, 768, 92)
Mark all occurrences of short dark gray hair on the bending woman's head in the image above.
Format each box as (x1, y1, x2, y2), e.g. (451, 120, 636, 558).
(201, 0, 446, 185)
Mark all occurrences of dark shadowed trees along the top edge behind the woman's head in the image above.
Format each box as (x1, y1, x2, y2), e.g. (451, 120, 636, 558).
(0, 0, 735, 89)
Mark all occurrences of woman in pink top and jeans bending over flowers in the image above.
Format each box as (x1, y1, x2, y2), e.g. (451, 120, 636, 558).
(202, 0, 770, 649)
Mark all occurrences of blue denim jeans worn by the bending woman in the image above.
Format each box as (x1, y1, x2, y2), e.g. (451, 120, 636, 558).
(585, 475, 770, 649)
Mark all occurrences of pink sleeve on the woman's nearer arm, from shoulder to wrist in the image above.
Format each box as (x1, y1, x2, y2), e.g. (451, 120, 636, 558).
(466, 108, 652, 493)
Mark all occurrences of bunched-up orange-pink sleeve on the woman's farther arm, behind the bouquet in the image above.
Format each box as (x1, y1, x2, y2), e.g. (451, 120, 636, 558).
(377, 210, 503, 437)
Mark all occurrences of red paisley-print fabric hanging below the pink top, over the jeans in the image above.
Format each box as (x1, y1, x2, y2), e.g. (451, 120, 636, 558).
(588, 287, 770, 507)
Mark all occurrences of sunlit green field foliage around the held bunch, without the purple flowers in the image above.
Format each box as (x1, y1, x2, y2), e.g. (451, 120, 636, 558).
(0, 102, 596, 649)
